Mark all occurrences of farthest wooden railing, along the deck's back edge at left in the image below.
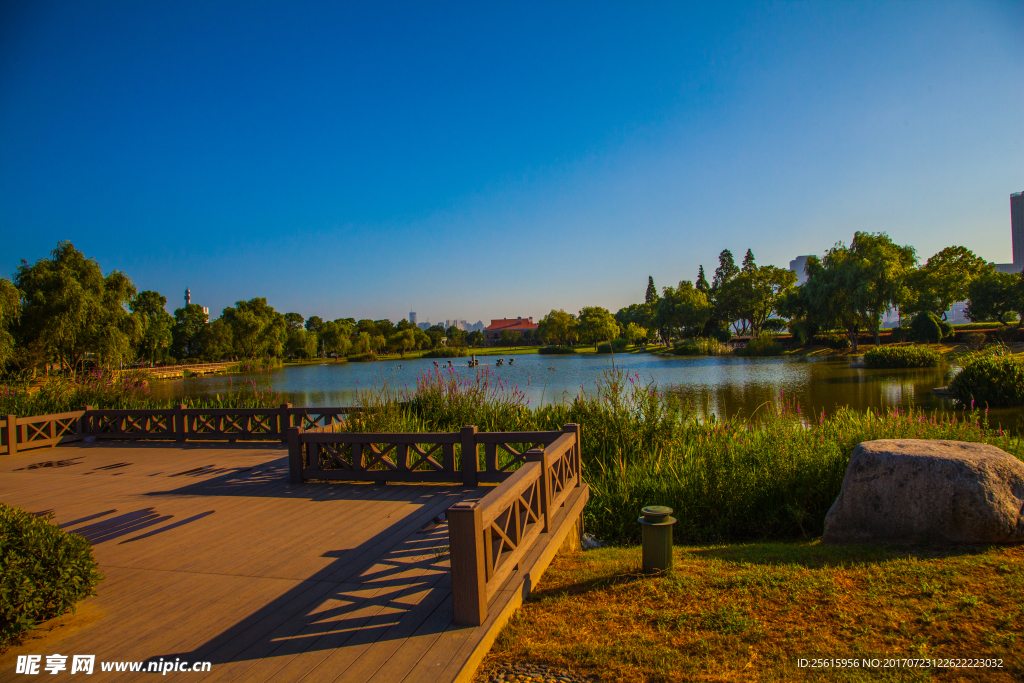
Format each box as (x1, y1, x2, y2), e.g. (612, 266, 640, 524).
(0, 403, 360, 455)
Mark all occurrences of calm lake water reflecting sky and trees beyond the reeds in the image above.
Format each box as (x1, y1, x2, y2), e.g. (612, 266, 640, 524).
(144, 354, 1024, 428)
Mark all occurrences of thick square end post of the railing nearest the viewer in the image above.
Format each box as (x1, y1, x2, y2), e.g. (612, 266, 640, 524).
(447, 501, 487, 626)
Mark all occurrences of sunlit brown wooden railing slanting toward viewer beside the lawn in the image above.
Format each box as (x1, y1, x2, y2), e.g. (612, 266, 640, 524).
(447, 425, 586, 626)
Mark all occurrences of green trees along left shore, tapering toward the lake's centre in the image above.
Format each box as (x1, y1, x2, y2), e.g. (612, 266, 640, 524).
(0, 242, 497, 374)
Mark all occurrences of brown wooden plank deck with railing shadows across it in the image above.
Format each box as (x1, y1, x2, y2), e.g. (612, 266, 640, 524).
(0, 442, 582, 683)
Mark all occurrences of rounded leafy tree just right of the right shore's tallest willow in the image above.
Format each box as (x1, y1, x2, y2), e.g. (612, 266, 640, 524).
(900, 247, 992, 319)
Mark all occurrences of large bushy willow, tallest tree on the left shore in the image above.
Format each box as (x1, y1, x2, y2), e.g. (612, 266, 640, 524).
(13, 242, 141, 375)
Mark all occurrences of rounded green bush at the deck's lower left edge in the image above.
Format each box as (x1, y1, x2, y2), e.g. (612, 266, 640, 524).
(0, 503, 103, 647)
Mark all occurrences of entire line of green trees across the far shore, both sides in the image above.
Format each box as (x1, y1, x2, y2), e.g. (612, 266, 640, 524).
(0, 232, 1024, 373)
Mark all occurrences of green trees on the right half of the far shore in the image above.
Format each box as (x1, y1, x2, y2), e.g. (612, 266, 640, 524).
(539, 232, 1024, 352)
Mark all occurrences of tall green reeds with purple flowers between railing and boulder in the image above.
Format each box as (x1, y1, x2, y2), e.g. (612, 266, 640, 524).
(360, 369, 1024, 544)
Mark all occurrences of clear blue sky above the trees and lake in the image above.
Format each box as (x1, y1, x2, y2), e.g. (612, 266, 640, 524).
(0, 0, 1024, 322)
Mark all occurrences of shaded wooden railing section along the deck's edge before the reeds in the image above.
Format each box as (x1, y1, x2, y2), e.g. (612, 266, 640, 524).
(288, 425, 571, 486)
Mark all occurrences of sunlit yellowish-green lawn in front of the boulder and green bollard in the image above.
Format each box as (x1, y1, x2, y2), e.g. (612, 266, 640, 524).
(478, 541, 1024, 682)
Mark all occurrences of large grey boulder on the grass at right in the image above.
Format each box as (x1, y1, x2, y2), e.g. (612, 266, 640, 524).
(822, 438, 1024, 543)
